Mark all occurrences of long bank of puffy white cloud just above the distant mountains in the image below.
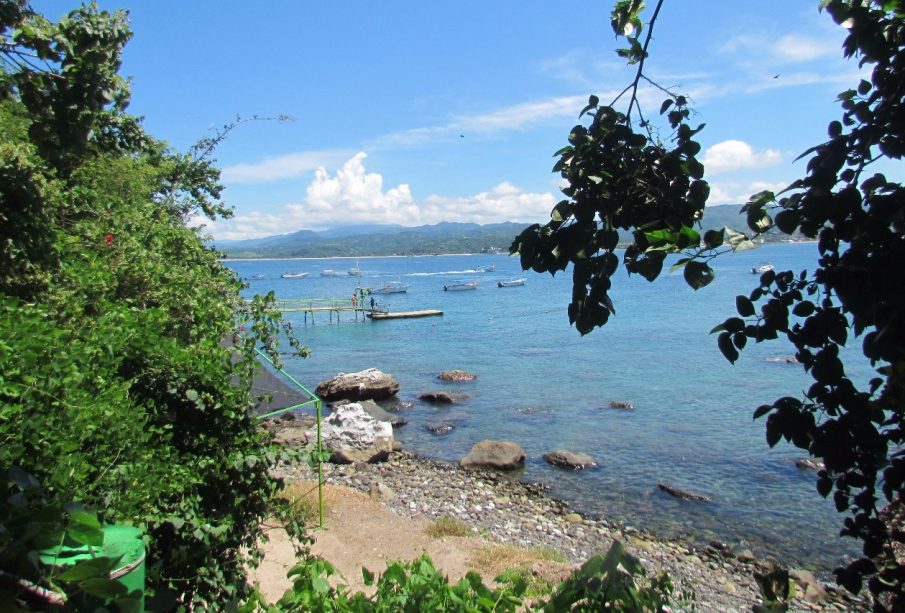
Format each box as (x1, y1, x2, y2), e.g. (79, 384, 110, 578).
(207, 152, 556, 240)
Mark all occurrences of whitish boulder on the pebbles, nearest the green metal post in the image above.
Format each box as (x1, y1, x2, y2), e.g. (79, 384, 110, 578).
(322, 402, 393, 464)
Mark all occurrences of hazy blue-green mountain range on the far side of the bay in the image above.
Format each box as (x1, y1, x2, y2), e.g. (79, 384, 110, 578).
(214, 204, 787, 258)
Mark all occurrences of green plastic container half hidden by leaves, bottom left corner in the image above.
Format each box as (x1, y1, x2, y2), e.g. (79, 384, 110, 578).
(40, 526, 145, 613)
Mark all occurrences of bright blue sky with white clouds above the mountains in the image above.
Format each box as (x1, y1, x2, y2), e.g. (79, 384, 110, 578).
(32, 0, 861, 239)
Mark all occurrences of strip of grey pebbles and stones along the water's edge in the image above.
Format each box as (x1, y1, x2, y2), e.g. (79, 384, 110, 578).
(278, 444, 869, 611)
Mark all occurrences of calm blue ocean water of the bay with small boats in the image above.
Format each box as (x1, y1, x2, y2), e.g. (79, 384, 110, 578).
(227, 243, 870, 572)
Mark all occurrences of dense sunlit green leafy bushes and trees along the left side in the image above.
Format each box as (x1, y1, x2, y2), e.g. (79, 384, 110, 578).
(0, 2, 308, 608)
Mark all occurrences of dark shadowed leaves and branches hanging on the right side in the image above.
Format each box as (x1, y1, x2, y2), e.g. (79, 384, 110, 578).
(511, 0, 905, 610)
